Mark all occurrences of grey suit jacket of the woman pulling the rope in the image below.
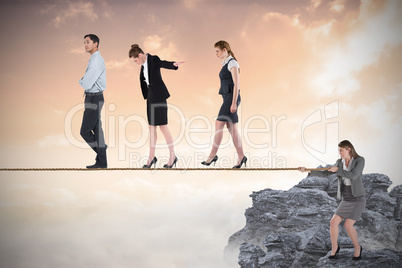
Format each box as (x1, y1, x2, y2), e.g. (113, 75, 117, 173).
(310, 156, 366, 199)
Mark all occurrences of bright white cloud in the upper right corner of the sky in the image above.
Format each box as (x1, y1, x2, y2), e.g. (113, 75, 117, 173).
(309, 1, 402, 98)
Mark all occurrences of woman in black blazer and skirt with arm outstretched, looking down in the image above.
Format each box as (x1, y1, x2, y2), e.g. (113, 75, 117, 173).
(128, 44, 184, 168)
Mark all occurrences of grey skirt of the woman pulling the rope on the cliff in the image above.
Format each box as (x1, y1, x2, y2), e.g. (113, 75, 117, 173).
(335, 184, 366, 221)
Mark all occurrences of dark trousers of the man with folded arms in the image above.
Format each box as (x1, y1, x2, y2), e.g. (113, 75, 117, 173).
(81, 93, 107, 167)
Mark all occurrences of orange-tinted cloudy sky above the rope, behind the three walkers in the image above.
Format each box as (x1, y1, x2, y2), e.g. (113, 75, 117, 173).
(0, 0, 402, 267)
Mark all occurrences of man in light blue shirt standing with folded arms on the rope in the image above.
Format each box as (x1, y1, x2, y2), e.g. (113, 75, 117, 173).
(79, 34, 107, 168)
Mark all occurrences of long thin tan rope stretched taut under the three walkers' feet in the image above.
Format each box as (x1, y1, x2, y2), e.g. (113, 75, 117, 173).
(0, 168, 328, 171)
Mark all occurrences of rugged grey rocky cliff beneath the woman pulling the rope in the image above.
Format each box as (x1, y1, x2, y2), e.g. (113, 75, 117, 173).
(225, 174, 402, 268)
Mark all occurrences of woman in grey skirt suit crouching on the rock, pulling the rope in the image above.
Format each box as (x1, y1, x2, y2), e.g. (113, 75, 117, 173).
(299, 140, 366, 260)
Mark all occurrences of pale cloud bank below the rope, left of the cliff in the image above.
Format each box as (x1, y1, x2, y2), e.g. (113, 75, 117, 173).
(0, 174, 267, 268)
